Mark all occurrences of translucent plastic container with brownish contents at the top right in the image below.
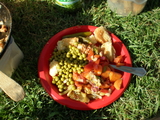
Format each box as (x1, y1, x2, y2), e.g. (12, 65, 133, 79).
(107, 0, 147, 16)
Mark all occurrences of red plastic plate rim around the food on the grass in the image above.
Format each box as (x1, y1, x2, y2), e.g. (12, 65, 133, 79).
(38, 25, 132, 110)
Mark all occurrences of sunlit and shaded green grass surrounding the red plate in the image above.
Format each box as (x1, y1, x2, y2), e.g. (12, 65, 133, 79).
(0, 0, 160, 120)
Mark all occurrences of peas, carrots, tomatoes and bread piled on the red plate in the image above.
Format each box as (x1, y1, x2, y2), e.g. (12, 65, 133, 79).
(49, 26, 123, 103)
